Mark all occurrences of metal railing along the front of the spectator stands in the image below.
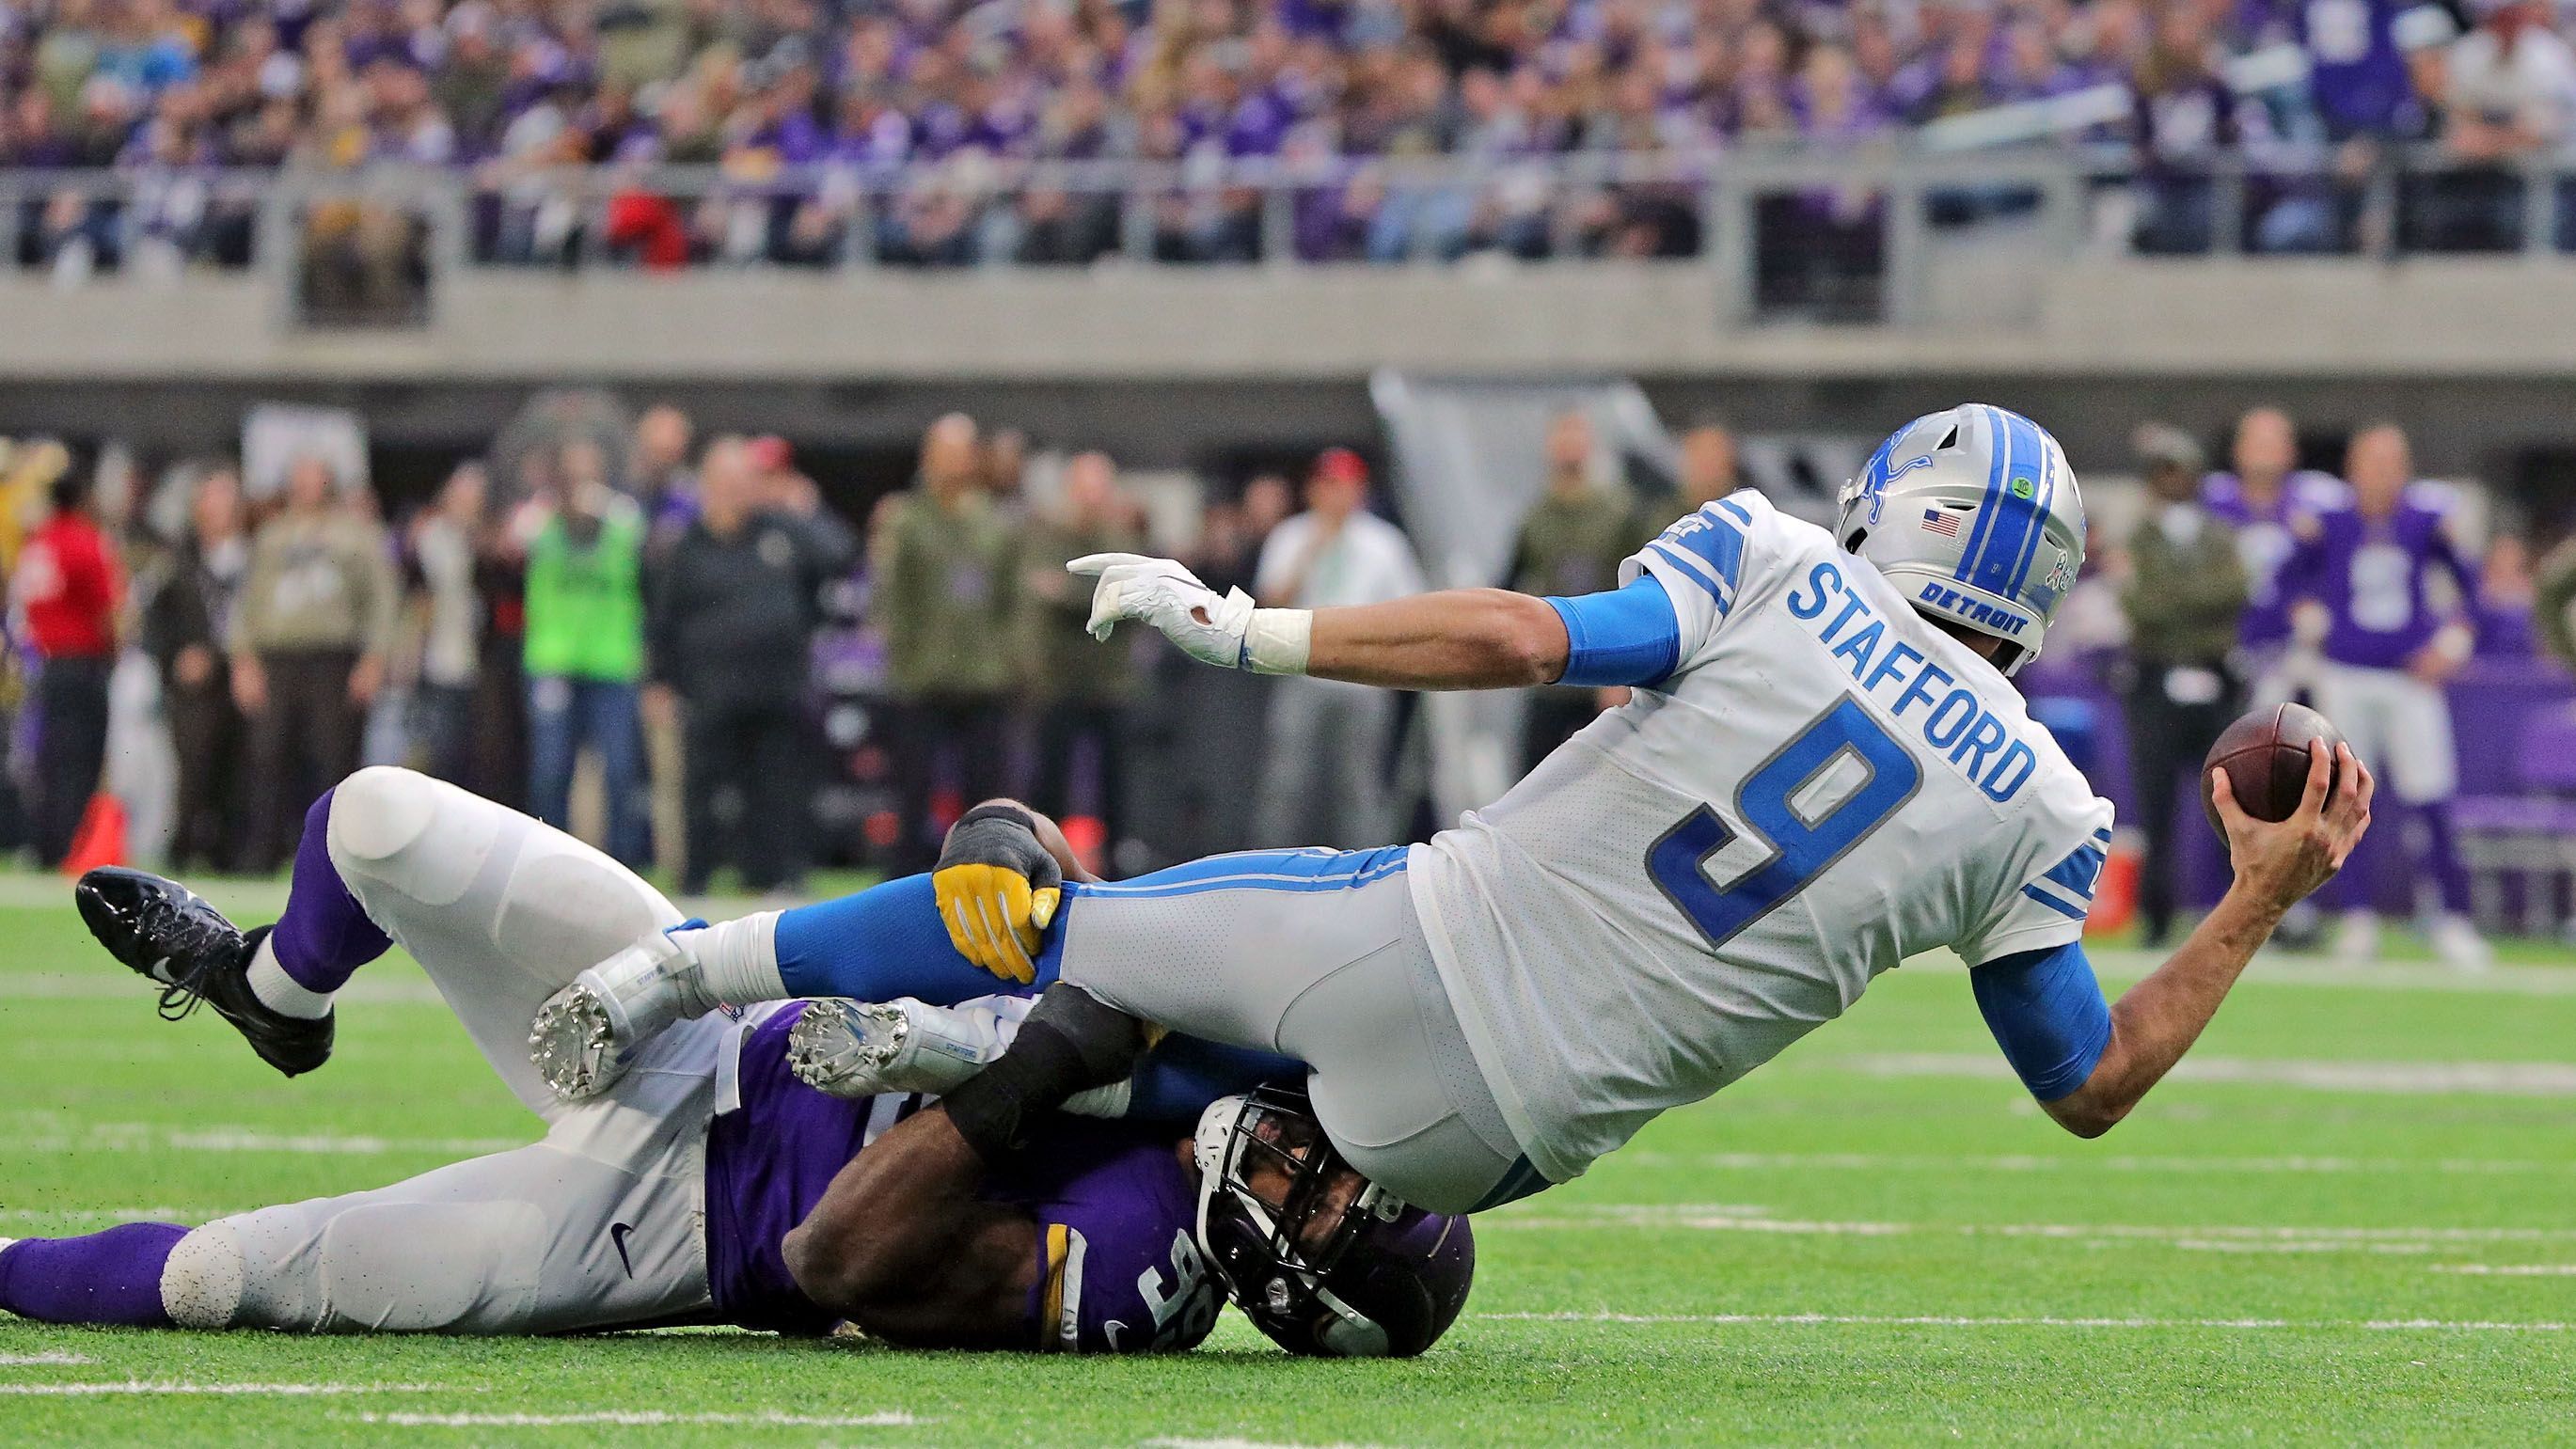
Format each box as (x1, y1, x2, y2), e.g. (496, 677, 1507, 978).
(15, 139, 2576, 324)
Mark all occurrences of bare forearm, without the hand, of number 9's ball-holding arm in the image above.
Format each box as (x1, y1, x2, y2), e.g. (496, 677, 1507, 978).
(2048, 886, 2283, 1138)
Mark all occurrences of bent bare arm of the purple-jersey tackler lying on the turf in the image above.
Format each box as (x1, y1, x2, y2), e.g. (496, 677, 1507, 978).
(783, 1104, 1038, 1348)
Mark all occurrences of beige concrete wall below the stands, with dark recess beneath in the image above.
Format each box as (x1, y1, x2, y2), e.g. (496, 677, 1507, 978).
(0, 252, 2576, 471)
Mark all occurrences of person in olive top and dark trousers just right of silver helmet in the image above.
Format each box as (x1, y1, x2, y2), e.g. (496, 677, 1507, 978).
(2112, 422, 2246, 947)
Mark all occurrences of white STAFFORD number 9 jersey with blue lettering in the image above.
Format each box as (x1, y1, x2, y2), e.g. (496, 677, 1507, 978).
(1409, 495, 2110, 1181)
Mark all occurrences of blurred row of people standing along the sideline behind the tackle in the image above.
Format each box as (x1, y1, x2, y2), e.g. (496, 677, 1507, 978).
(0, 404, 2576, 963)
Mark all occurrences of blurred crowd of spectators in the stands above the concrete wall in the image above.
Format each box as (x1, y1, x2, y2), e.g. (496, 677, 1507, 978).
(15, 0, 2576, 273)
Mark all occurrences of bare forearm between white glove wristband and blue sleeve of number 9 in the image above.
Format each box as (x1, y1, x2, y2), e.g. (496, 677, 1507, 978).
(1306, 590, 1566, 690)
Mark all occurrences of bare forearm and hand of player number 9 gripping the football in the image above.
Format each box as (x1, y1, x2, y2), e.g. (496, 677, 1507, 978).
(2043, 741, 2378, 1138)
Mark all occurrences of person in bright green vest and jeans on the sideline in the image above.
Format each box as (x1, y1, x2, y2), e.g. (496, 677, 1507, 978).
(520, 443, 652, 867)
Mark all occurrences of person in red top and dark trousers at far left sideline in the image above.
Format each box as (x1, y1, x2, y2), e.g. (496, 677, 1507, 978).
(15, 474, 123, 867)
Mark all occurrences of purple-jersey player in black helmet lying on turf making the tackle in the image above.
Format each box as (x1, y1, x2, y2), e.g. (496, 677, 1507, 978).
(0, 767, 1474, 1354)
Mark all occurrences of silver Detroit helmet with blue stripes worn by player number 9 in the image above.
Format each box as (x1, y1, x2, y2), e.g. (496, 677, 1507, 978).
(1834, 402, 2084, 674)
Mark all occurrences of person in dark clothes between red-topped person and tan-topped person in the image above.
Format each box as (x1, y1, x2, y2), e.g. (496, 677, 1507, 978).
(142, 465, 250, 870)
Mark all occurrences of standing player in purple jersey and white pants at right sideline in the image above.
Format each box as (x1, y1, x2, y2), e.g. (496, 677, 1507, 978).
(2283, 422, 2489, 970)
